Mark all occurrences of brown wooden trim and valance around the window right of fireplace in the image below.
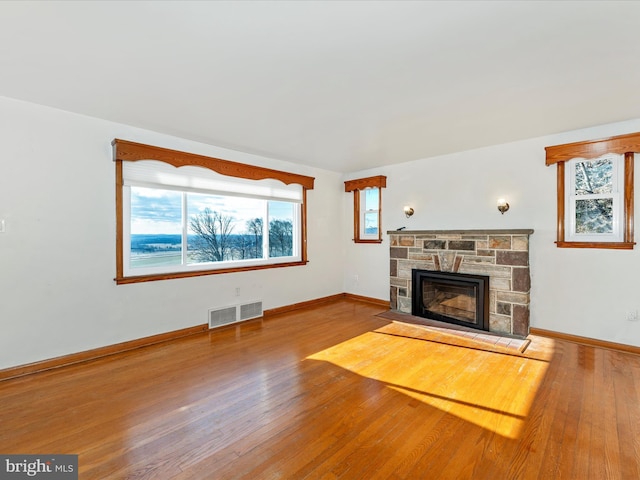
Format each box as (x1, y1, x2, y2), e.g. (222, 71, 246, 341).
(545, 133, 640, 250)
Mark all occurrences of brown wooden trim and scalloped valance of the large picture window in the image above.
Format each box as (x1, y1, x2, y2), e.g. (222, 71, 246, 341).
(111, 139, 315, 285)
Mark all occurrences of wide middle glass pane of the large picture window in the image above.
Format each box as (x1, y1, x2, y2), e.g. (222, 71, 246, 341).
(187, 194, 266, 264)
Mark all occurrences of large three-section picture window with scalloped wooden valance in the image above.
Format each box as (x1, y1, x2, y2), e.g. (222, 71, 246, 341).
(114, 140, 313, 283)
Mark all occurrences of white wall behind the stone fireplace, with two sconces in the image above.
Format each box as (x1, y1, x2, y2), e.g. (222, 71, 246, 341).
(343, 119, 640, 346)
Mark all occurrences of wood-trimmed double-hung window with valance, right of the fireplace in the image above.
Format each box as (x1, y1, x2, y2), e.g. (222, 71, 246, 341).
(545, 133, 640, 249)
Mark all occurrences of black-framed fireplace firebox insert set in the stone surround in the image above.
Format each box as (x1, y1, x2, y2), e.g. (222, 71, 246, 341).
(411, 269, 489, 331)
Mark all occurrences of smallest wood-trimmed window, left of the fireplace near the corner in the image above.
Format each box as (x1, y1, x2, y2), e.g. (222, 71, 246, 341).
(344, 175, 387, 243)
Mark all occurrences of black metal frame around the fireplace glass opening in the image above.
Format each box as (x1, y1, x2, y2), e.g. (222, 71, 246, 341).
(411, 268, 489, 332)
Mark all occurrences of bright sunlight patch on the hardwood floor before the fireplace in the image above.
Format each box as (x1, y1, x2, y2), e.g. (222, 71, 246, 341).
(307, 332, 548, 439)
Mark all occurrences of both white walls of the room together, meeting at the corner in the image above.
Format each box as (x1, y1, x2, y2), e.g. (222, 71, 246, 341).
(0, 93, 640, 369)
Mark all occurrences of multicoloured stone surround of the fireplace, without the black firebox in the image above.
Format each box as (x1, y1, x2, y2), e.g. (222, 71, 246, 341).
(387, 230, 533, 337)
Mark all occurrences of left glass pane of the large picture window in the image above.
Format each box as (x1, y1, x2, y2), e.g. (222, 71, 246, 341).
(129, 187, 182, 268)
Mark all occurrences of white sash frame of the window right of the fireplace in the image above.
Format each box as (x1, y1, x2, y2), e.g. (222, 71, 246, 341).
(565, 154, 624, 242)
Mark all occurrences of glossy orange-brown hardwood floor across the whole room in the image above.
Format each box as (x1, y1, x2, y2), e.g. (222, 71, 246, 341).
(0, 300, 640, 480)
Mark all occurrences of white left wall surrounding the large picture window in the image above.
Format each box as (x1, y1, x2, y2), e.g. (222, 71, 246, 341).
(0, 97, 344, 369)
